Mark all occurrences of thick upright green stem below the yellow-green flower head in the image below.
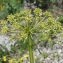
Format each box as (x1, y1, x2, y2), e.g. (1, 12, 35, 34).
(28, 32, 34, 63)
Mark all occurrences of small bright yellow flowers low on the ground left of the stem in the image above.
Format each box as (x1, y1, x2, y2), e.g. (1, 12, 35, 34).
(3, 54, 29, 63)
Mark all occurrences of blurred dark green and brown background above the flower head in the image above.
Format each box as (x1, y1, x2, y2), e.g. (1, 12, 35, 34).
(0, 0, 63, 19)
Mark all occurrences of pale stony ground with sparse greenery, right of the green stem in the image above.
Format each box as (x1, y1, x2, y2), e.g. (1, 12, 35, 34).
(34, 33, 63, 63)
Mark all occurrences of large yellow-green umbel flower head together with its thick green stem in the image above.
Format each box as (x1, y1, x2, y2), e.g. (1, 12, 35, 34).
(0, 8, 62, 63)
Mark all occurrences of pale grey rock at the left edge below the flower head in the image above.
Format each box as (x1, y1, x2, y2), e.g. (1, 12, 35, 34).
(0, 35, 15, 51)
